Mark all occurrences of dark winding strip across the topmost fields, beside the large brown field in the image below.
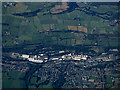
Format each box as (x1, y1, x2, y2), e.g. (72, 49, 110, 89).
(13, 2, 118, 20)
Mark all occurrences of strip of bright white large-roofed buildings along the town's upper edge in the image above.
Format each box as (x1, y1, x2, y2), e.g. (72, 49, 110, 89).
(11, 49, 119, 63)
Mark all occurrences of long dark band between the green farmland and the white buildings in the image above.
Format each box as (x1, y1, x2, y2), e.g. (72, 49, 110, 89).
(3, 40, 116, 54)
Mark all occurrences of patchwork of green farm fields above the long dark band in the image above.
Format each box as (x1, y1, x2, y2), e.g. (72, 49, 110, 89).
(2, 3, 118, 50)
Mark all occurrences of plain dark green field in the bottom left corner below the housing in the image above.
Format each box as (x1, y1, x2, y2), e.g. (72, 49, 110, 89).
(2, 71, 25, 88)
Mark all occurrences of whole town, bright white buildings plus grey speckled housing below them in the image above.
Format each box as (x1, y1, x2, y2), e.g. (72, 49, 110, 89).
(3, 49, 119, 88)
